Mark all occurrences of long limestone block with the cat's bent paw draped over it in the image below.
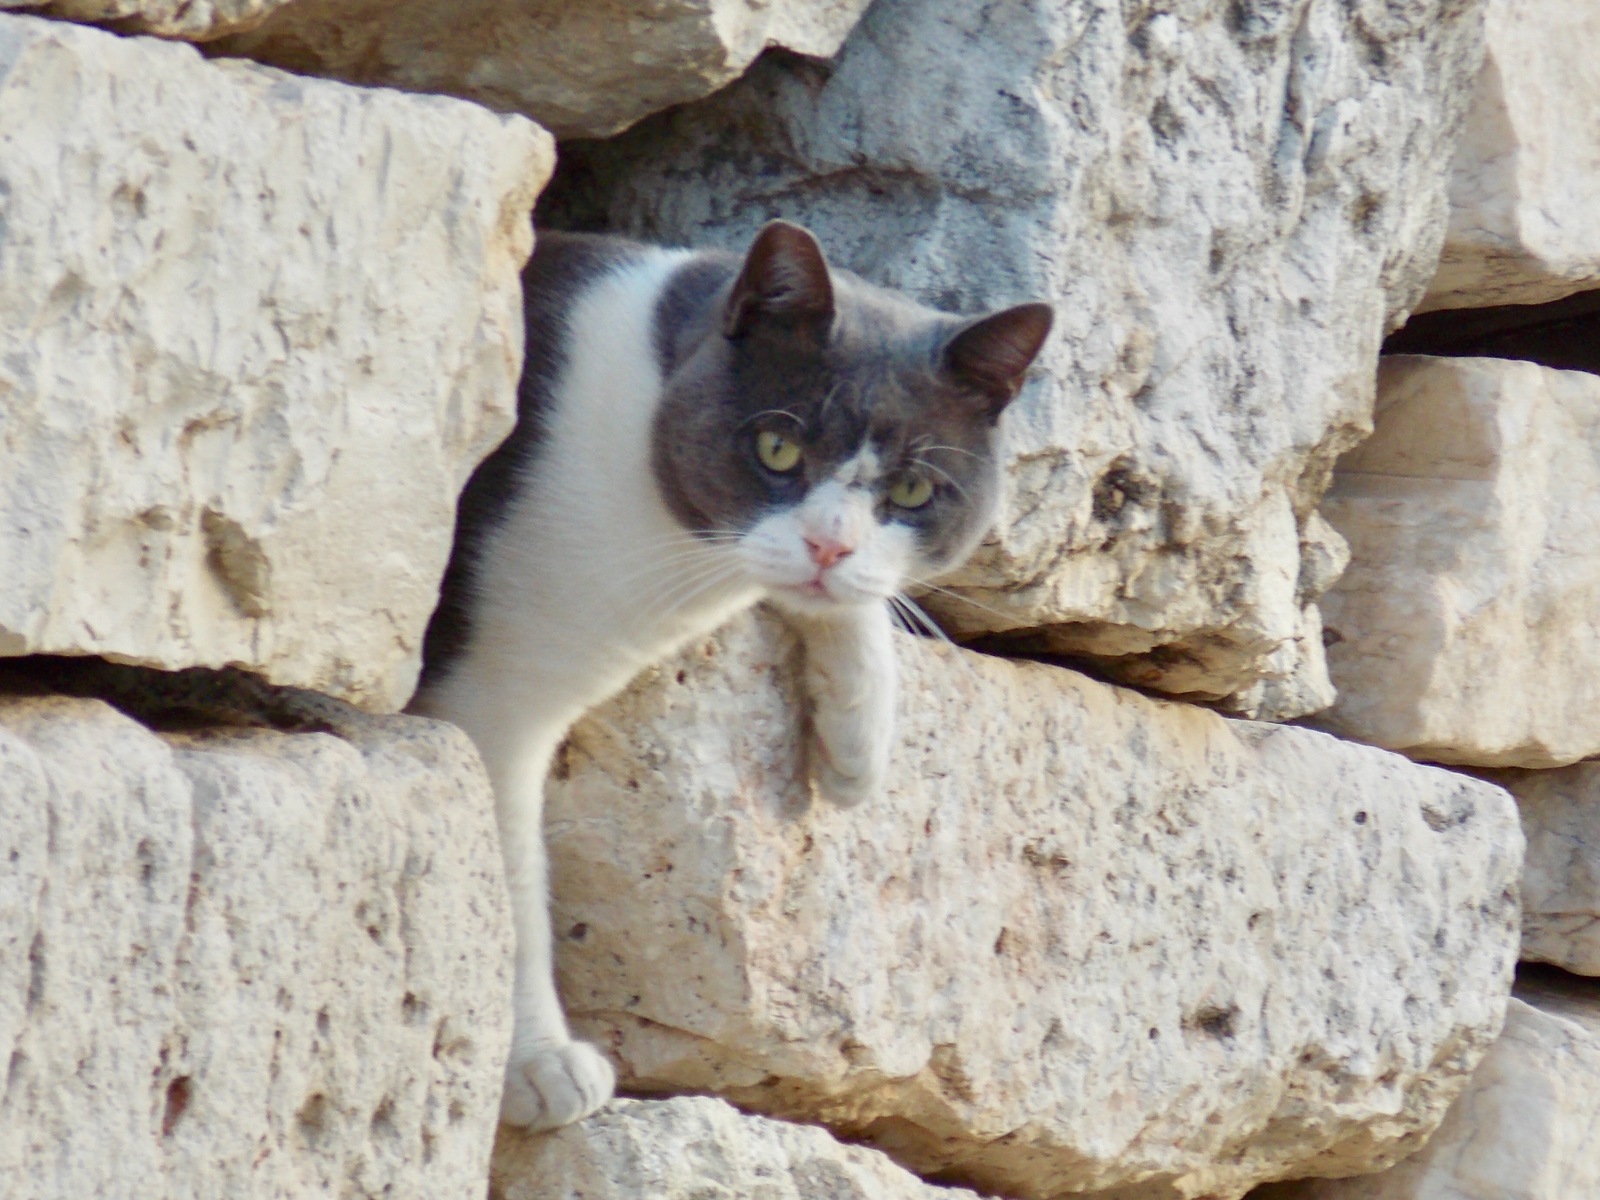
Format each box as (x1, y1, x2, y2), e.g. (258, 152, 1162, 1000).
(546, 619, 1522, 1198)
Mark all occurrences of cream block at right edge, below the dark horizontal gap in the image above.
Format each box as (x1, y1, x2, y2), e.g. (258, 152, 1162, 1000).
(1317, 355, 1600, 766)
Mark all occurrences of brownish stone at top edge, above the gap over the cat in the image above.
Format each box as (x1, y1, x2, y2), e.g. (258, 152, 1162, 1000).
(216, 0, 867, 138)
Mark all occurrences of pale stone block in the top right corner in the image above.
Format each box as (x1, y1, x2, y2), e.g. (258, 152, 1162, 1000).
(1419, 0, 1600, 312)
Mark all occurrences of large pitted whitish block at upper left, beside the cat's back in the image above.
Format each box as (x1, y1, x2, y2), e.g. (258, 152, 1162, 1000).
(0, 16, 552, 709)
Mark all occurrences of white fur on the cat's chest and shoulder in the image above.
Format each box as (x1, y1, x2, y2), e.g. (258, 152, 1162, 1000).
(421, 250, 760, 800)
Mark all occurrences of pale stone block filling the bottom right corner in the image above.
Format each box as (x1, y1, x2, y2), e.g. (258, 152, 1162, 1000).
(1259, 986, 1600, 1200)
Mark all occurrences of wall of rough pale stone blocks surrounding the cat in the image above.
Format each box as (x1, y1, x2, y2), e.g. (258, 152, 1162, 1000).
(0, 0, 1600, 1200)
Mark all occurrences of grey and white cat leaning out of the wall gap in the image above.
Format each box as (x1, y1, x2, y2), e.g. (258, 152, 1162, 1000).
(413, 221, 1051, 1128)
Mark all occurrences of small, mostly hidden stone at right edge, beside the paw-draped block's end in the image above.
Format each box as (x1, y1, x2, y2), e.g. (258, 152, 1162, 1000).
(1472, 762, 1600, 974)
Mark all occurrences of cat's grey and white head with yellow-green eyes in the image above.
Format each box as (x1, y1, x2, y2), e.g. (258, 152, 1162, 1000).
(653, 221, 1051, 611)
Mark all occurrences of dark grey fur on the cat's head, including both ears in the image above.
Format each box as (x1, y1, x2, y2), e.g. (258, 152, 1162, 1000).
(653, 226, 1050, 588)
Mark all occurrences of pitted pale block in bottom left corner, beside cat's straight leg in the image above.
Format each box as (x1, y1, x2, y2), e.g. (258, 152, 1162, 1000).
(0, 684, 510, 1200)
